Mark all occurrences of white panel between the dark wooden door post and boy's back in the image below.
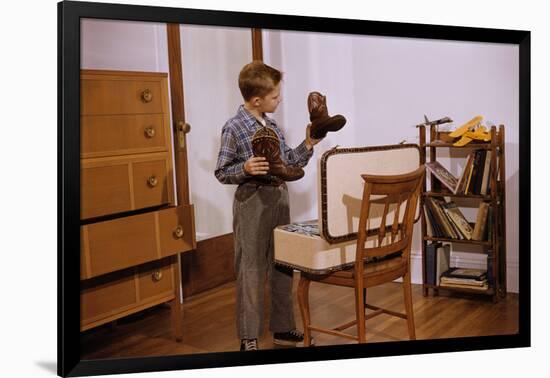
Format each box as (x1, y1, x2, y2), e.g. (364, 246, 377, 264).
(180, 25, 252, 240)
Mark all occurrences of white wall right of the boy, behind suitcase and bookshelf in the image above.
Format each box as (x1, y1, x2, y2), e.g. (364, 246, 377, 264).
(264, 31, 519, 292)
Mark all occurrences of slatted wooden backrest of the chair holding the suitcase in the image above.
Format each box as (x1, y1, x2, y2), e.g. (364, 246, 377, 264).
(356, 166, 425, 266)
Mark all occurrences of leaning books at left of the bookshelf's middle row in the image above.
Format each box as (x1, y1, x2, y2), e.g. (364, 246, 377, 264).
(424, 197, 474, 240)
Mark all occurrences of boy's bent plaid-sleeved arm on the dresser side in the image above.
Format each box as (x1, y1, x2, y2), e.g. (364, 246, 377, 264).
(214, 128, 248, 185)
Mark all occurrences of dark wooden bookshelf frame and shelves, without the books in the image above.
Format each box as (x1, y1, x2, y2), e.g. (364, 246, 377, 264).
(418, 125, 506, 302)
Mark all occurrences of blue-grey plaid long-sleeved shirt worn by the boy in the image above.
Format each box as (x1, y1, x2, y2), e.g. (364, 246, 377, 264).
(215, 105, 313, 184)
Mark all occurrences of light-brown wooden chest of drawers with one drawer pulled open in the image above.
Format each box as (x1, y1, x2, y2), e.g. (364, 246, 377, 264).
(80, 70, 196, 338)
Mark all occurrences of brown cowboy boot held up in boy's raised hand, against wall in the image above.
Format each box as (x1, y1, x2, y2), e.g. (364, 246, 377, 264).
(307, 92, 346, 139)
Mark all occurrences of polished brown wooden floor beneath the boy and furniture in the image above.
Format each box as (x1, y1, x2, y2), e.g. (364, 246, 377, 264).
(81, 276, 518, 359)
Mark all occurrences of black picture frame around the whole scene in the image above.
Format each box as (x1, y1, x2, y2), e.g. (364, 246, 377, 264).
(57, 1, 531, 376)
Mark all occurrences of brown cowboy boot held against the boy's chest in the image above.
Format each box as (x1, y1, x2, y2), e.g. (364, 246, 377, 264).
(252, 127, 304, 181)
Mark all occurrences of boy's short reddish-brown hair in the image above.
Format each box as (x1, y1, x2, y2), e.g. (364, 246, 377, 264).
(239, 60, 283, 101)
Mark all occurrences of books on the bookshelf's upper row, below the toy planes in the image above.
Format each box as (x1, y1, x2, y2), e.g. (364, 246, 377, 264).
(426, 150, 491, 195)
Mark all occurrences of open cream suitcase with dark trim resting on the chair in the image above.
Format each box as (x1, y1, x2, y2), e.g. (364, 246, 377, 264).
(274, 144, 420, 274)
